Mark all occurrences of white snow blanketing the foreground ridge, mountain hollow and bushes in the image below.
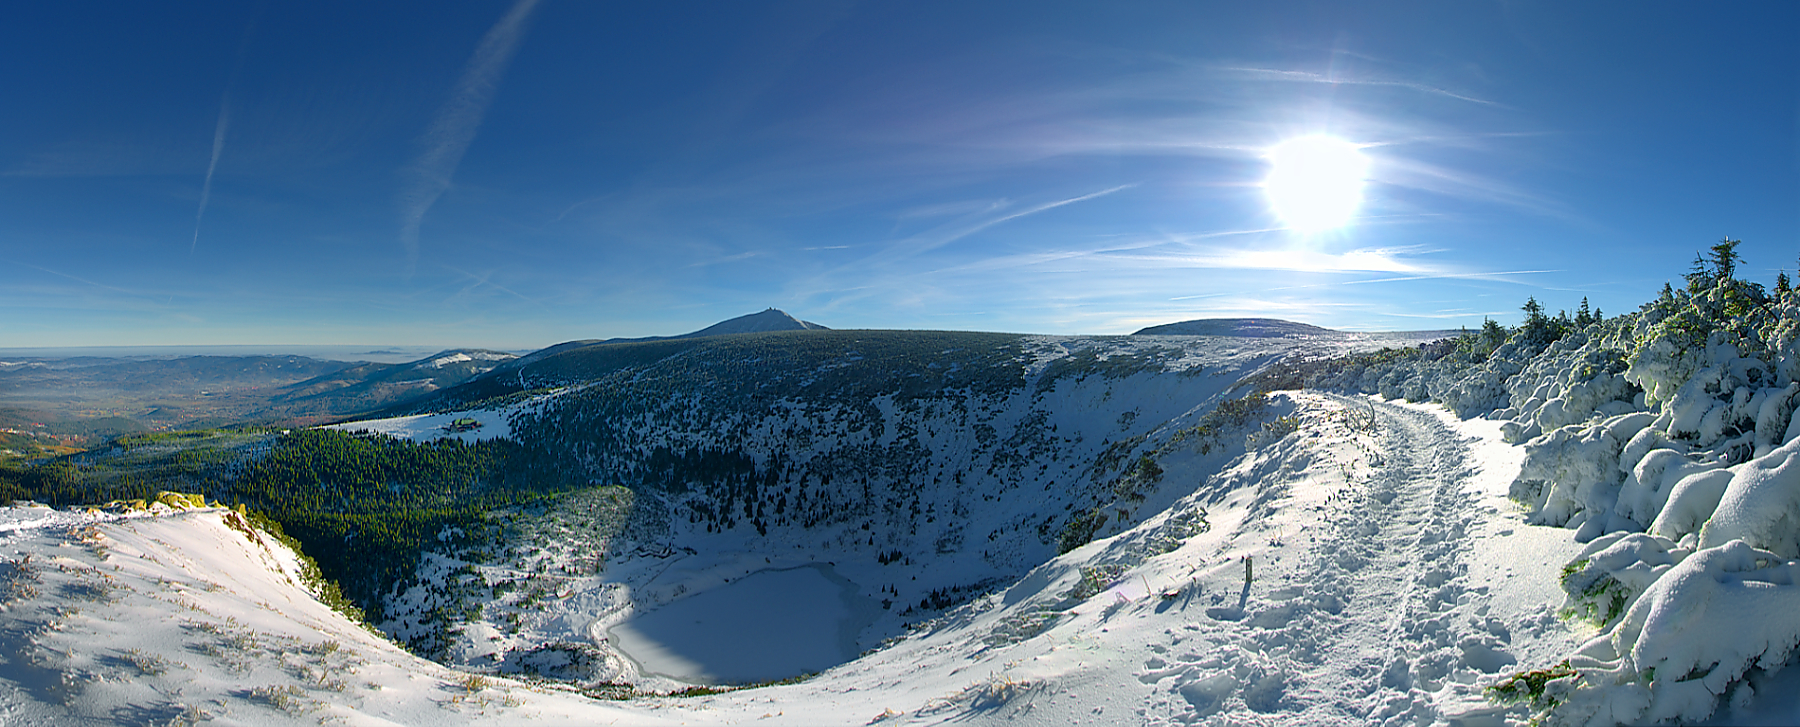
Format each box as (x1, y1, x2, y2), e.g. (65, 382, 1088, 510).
(17, 305, 1800, 725)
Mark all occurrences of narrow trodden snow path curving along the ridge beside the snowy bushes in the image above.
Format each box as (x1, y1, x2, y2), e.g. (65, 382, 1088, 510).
(1305, 394, 1516, 723)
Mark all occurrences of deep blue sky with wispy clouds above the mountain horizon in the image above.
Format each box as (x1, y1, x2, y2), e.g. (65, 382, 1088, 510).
(0, 0, 1800, 349)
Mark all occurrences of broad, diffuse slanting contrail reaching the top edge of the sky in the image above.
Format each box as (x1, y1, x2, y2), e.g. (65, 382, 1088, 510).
(400, 0, 538, 279)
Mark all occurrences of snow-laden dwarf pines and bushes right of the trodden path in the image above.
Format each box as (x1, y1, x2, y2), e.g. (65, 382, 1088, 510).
(1339, 275, 1800, 725)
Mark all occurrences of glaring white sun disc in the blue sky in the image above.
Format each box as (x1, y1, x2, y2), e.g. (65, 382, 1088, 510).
(1264, 135, 1368, 234)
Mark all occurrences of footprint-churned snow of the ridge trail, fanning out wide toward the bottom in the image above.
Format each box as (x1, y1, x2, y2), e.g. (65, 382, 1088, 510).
(1139, 394, 1516, 725)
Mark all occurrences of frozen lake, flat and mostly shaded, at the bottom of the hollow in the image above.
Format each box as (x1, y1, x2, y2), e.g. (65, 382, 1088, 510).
(607, 563, 875, 684)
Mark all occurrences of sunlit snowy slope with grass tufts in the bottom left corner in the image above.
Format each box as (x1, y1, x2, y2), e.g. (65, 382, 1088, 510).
(0, 506, 675, 725)
